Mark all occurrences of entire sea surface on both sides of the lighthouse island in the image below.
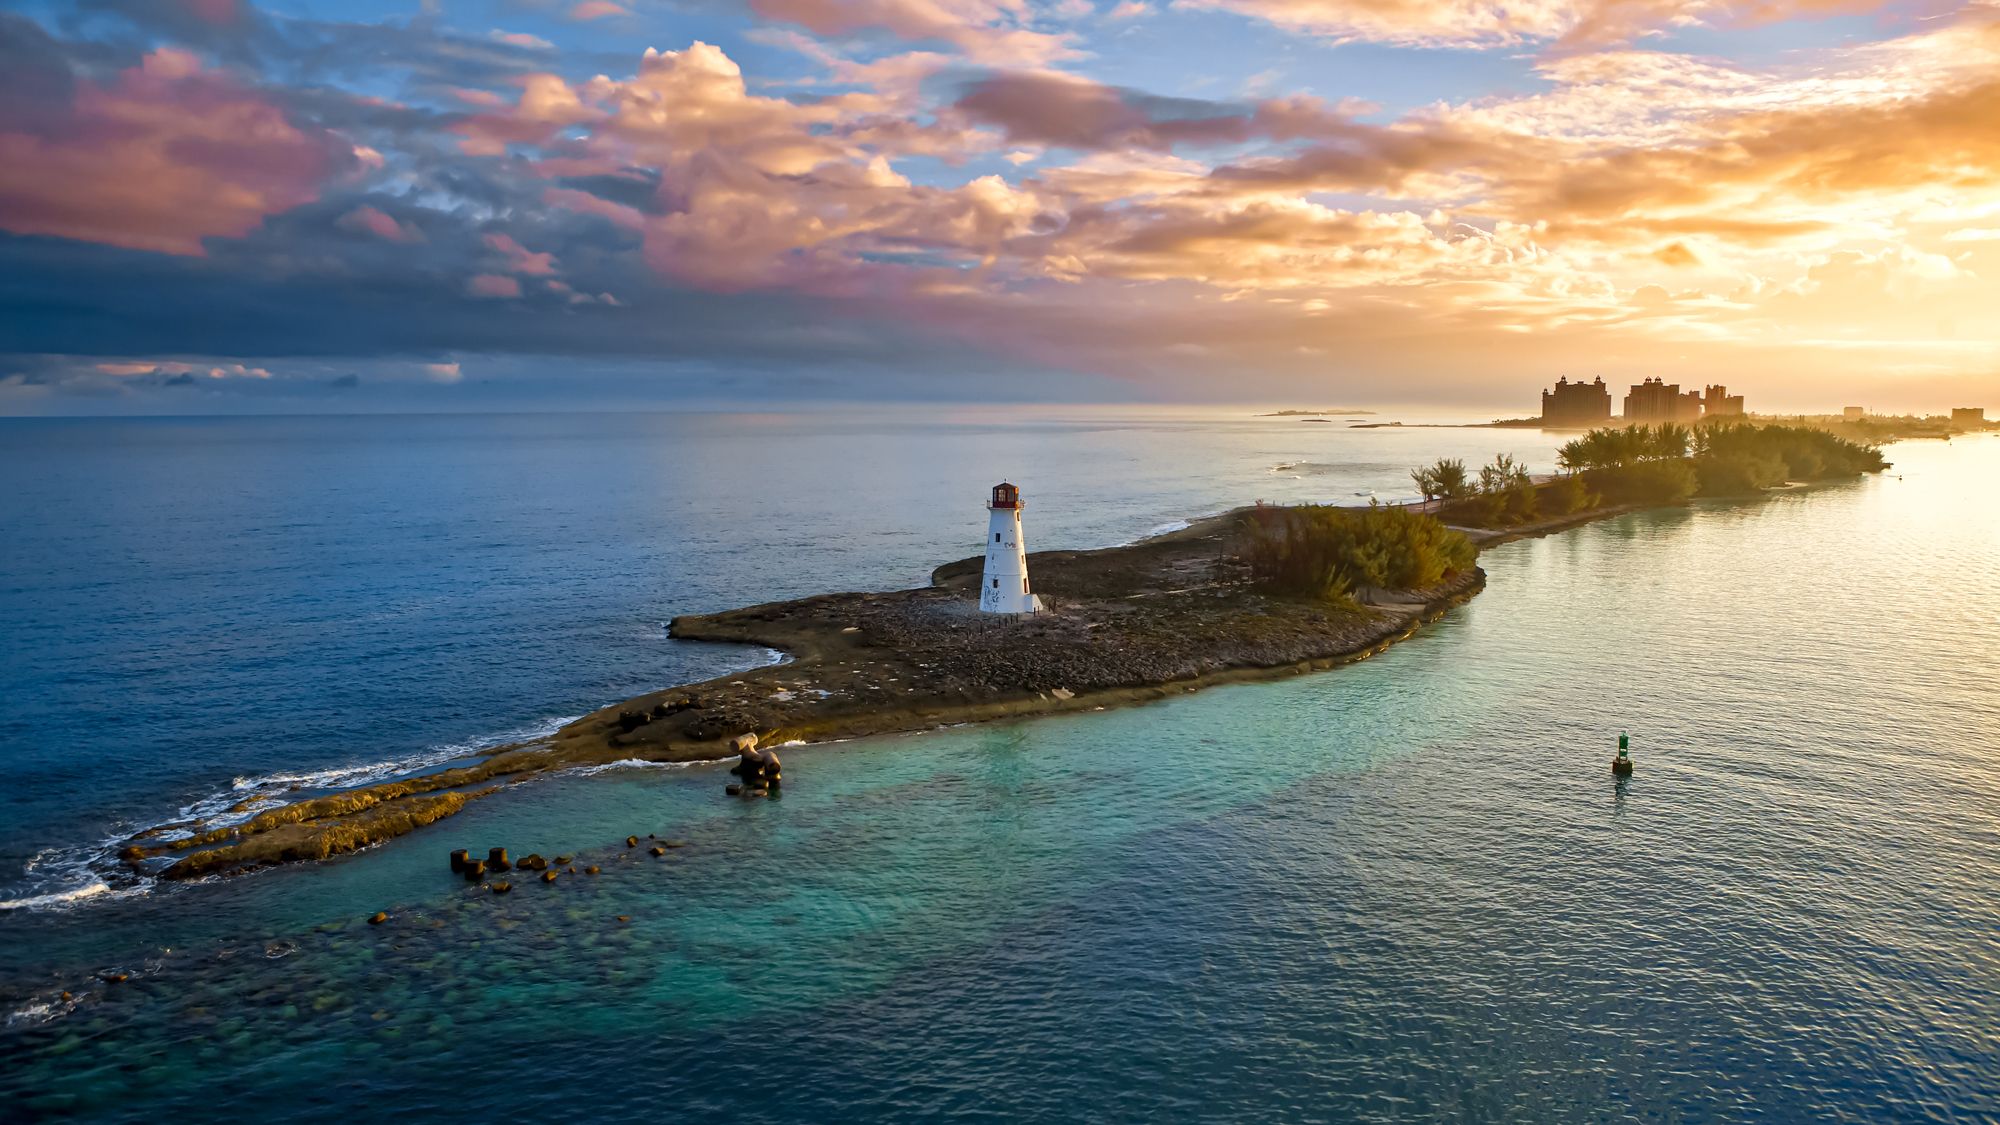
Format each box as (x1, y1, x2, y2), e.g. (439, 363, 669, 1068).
(0, 410, 2000, 1123)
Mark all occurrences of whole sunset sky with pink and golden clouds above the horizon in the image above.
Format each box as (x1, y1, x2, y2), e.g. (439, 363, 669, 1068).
(0, 0, 2000, 414)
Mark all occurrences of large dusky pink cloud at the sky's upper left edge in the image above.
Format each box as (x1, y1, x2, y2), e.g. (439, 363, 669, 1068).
(0, 48, 356, 256)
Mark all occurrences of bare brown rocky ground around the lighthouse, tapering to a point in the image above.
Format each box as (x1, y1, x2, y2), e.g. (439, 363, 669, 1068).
(122, 510, 1504, 879)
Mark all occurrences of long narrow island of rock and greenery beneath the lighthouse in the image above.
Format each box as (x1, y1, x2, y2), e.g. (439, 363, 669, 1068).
(120, 418, 1886, 879)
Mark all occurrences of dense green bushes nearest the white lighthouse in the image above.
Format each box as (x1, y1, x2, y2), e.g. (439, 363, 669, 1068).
(1236, 504, 1476, 603)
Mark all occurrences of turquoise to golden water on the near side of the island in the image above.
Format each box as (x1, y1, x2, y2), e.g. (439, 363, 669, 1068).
(0, 416, 2000, 1121)
